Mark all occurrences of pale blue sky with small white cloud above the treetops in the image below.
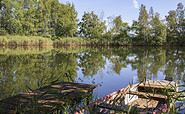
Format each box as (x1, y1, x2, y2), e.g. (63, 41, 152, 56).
(59, 0, 185, 24)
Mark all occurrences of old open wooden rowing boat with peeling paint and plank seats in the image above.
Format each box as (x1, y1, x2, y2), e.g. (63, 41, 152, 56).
(76, 80, 178, 114)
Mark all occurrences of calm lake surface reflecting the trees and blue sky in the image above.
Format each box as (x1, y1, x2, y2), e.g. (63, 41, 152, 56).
(0, 47, 185, 99)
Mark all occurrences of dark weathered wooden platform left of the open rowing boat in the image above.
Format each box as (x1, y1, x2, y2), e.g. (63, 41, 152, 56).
(0, 82, 97, 113)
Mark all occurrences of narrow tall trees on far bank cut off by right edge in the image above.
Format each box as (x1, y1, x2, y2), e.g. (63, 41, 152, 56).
(166, 3, 185, 45)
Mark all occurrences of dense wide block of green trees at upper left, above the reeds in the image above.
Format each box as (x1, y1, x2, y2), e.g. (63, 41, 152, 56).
(1, 0, 77, 36)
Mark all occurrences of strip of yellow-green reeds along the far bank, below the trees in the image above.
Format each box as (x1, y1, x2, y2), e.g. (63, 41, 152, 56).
(0, 35, 184, 47)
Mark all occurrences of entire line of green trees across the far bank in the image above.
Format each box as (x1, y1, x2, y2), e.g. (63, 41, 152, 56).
(0, 0, 185, 45)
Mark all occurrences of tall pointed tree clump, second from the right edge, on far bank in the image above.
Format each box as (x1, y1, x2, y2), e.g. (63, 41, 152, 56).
(131, 5, 167, 45)
